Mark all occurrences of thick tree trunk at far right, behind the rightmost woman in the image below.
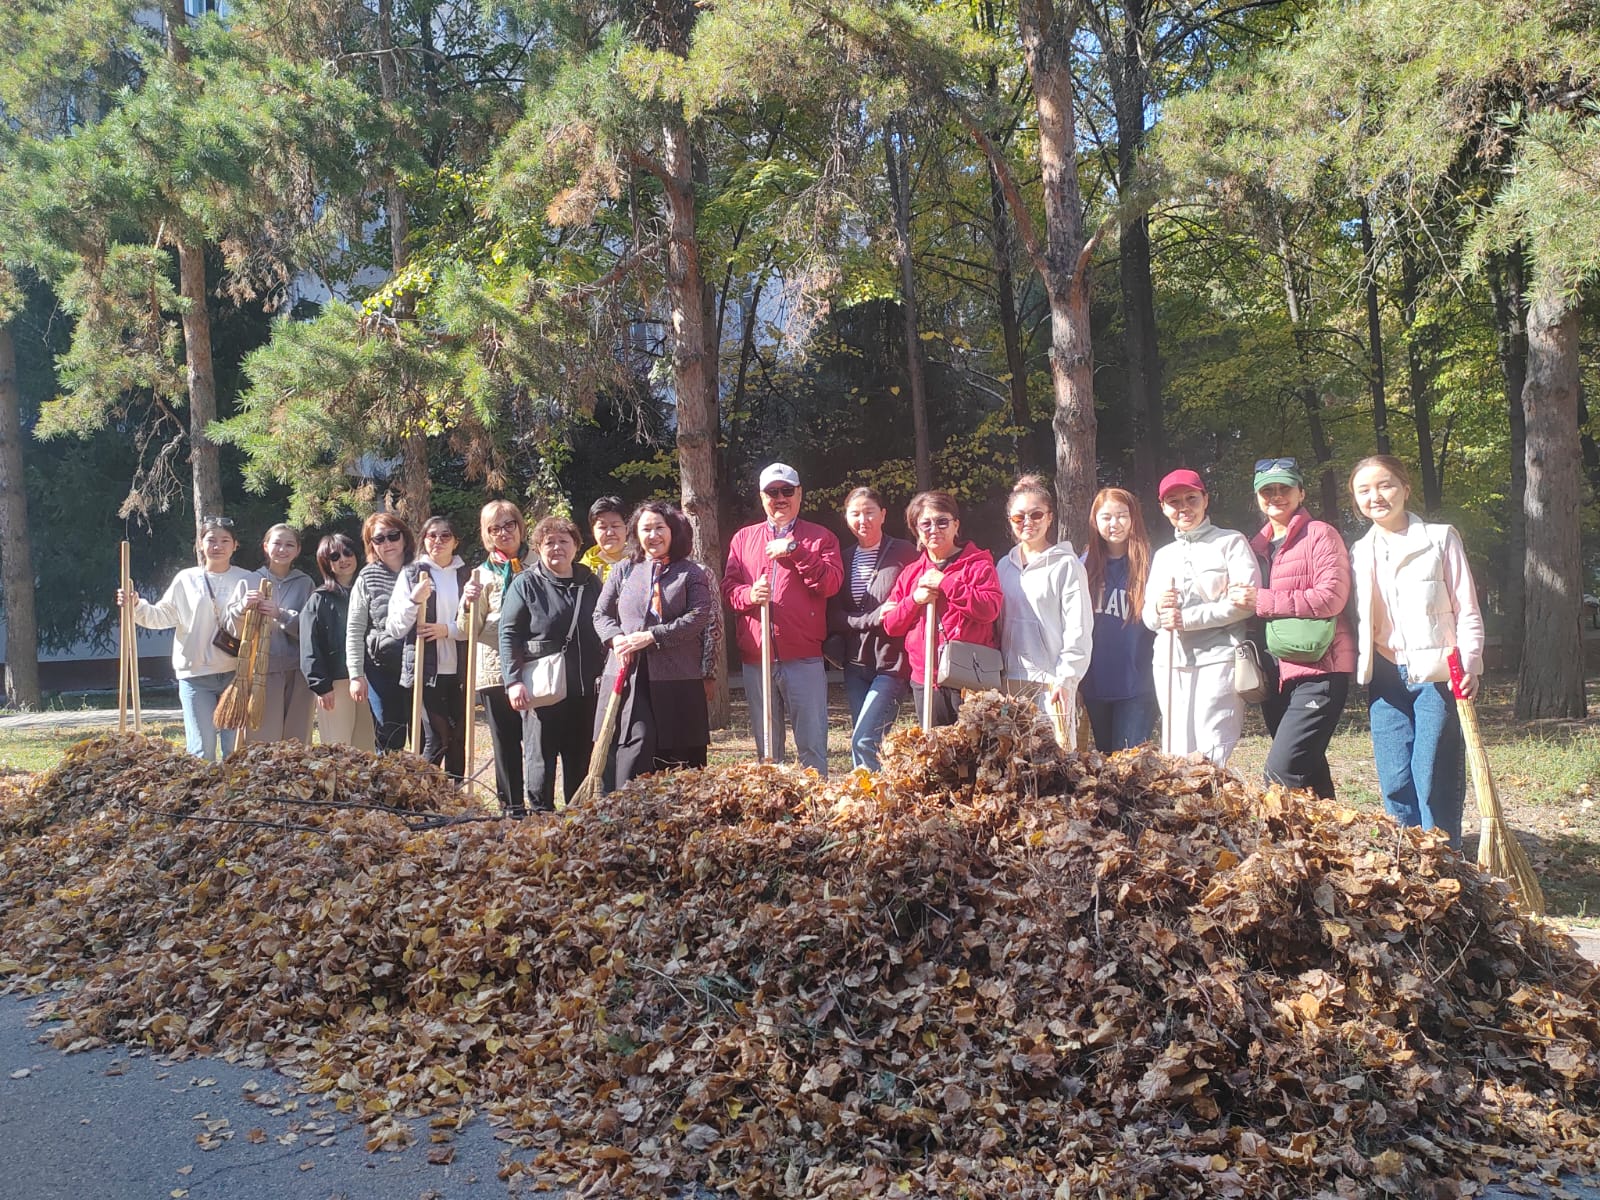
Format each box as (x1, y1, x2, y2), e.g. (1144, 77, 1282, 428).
(1517, 272, 1586, 720)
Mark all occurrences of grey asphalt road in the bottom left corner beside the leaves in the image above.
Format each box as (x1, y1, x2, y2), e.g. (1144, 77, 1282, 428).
(0, 998, 507, 1200)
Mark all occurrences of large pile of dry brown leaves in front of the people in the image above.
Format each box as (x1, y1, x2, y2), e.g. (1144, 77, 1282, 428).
(0, 694, 1600, 1197)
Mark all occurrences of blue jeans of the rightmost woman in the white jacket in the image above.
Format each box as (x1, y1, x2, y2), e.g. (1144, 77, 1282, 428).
(1366, 654, 1467, 848)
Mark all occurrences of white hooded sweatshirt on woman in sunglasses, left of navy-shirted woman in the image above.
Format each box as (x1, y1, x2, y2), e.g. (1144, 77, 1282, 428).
(995, 541, 1094, 686)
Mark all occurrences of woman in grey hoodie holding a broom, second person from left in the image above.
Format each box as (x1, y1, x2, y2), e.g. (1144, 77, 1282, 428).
(227, 525, 312, 742)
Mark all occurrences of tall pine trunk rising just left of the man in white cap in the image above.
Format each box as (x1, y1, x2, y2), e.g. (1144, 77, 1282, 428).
(661, 115, 728, 725)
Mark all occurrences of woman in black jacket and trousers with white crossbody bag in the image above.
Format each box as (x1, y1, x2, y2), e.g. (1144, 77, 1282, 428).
(499, 517, 603, 811)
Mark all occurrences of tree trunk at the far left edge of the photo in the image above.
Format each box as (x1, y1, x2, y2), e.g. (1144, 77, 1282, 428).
(0, 323, 40, 709)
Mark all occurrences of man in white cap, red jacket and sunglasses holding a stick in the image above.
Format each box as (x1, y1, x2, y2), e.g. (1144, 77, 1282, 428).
(722, 462, 845, 774)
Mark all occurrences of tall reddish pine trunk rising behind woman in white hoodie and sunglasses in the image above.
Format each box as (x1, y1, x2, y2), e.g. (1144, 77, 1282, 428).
(1008, 0, 1096, 544)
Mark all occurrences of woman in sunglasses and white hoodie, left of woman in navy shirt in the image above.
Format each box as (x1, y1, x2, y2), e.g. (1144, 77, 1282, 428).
(998, 475, 1094, 749)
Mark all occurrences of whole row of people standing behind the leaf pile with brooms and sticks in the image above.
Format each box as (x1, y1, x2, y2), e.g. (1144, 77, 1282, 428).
(118, 456, 1483, 838)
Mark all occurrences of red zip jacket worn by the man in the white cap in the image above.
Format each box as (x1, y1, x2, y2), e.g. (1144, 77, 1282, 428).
(722, 520, 845, 666)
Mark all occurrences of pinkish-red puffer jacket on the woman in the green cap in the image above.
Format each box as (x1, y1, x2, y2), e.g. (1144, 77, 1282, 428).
(1250, 509, 1355, 683)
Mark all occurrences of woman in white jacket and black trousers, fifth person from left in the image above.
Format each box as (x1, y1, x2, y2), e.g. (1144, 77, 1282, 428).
(384, 517, 472, 779)
